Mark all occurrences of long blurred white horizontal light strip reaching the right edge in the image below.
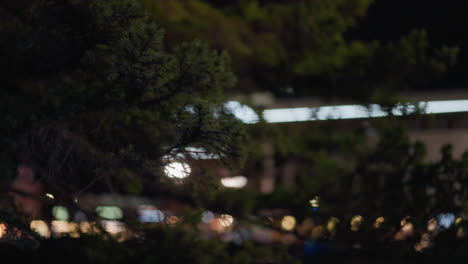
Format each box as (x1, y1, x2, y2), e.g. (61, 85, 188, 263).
(263, 100, 468, 123)
